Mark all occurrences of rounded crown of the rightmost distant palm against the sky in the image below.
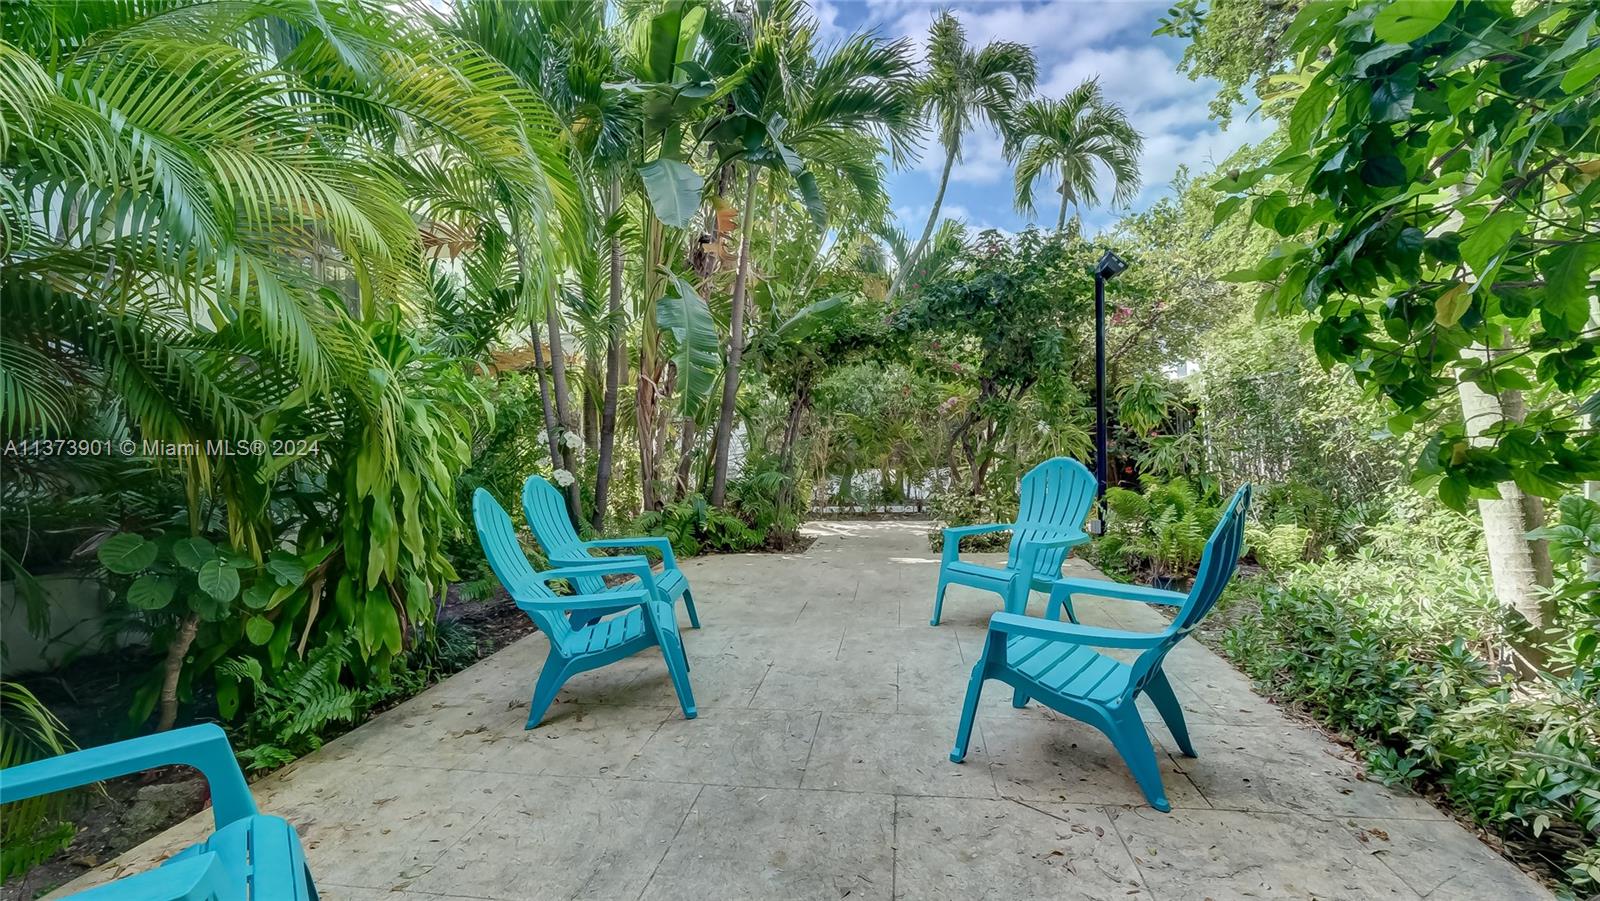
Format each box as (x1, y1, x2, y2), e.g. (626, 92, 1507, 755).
(1006, 78, 1144, 232)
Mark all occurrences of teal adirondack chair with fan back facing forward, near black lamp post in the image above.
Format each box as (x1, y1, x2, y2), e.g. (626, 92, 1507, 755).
(930, 456, 1094, 626)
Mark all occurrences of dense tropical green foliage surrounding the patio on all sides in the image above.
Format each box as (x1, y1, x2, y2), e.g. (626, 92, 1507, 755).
(0, 0, 1600, 893)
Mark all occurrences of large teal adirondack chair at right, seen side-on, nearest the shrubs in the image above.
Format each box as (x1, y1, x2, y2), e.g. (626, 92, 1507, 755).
(950, 485, 1250, 811)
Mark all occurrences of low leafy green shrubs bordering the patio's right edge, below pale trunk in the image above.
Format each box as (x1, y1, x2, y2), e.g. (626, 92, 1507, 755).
(1221, 547, 1600, 891)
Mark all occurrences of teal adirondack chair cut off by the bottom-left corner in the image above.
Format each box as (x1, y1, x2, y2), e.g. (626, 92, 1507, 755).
(0, 723, 317, 901)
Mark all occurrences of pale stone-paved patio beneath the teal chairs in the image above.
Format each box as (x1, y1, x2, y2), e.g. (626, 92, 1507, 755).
(59, 522, 1550, 901)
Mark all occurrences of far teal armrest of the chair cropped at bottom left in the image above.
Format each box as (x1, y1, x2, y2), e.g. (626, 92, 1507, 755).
(0, 723, 256, 829)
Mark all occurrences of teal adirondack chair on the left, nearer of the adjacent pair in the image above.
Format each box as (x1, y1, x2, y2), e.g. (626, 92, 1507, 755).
(472, 488, 694, 728)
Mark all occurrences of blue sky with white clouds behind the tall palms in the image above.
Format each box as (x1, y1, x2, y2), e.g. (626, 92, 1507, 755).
(813, 0, 1270, 237)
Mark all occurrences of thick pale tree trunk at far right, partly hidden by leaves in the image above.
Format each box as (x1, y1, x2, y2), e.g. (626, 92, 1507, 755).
(1459, 346, 1555, 640)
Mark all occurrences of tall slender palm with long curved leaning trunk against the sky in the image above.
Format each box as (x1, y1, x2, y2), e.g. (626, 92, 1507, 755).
(890, 11, 1038, 298)
